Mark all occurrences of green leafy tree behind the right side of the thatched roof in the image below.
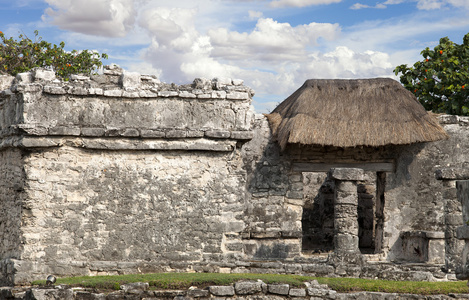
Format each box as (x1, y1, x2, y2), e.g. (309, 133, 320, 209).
(394, 33, 469, 115)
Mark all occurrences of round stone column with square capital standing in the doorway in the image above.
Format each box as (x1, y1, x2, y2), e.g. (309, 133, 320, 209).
(330, 168, 364, 253)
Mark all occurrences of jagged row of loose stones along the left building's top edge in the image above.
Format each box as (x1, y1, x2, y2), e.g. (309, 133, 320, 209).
(0, 65, 254, 100)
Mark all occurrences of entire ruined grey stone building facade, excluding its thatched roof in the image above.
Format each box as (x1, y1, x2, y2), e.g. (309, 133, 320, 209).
(0, 67, 469, 284)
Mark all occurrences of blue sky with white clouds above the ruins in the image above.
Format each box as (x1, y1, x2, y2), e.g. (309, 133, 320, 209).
(0, 0, 469, 112)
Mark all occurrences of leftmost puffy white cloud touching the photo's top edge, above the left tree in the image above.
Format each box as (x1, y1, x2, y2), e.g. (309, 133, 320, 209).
(43, 0, 136, 37)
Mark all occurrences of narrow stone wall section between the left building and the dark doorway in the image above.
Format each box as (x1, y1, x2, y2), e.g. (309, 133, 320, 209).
(240, 115, 304, 260)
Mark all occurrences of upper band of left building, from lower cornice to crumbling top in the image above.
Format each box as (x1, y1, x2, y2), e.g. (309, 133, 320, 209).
(0, 65, 254, 151)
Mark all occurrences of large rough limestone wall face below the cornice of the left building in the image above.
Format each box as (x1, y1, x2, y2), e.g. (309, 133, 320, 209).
(19, 146, 245, 274)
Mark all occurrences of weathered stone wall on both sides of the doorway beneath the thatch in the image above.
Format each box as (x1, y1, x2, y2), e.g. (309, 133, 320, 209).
(239, 116, 469, 272)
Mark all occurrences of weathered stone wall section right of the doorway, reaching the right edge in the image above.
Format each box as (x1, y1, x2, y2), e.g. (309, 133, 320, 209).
(384, 116, 469, 271)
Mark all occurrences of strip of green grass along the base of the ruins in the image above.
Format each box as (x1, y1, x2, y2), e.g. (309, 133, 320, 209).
(33, 273, 469, 295)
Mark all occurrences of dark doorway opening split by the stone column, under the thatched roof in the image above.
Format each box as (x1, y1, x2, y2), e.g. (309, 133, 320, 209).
(302, 171, 386, 254)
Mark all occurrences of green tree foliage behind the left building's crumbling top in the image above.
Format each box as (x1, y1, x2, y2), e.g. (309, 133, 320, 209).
(0, 30, 108, 80)
